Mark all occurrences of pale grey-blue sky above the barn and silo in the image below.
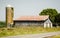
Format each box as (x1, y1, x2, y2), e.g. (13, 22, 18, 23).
(0, 0, 60, 21)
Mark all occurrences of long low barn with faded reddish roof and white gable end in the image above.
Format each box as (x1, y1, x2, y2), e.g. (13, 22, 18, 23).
(14, 15, 52, 28)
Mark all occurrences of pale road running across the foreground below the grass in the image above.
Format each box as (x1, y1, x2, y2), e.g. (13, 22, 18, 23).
(1, 31, 60, 38)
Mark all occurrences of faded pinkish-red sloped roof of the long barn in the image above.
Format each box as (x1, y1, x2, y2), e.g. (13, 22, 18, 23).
(15, 15, 49, 21)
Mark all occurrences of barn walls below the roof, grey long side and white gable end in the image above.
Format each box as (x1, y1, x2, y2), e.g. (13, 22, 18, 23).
(14, 19, 52, 27)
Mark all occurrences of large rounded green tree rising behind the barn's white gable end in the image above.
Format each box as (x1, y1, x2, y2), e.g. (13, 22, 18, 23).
(39, 8, 58, 22)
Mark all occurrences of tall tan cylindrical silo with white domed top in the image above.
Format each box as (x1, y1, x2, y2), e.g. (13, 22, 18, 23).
(6, 5, 14, 27)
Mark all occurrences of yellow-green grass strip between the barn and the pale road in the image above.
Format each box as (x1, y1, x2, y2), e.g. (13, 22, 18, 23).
(0, 26, 60, 37)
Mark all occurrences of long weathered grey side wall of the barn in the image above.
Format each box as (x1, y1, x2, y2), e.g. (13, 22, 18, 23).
(15, 21, 44, 26)
